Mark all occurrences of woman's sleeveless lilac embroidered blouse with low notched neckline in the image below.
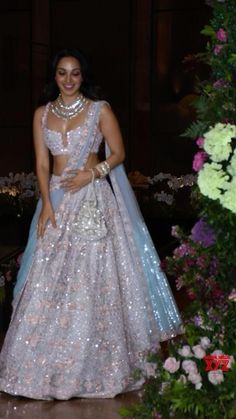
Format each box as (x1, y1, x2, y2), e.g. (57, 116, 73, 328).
(42, 101, 106, 156)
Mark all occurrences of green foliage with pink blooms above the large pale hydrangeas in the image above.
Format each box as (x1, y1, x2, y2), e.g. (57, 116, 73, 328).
(185, 0, 236, 139)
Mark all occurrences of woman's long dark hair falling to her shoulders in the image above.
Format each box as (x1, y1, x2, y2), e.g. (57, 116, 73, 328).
(40, 48, 105, 104)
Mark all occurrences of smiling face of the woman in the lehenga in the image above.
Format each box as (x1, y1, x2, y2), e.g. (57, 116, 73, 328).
(55, 57, 83, 97)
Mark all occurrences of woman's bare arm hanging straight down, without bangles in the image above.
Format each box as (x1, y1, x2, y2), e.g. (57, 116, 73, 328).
(33, 106, 56, 236)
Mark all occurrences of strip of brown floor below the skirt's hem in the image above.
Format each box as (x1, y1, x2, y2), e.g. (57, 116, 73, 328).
(0, 392, 140, 419)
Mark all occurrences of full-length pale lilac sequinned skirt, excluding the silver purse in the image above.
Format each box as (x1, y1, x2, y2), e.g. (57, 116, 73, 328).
(0, 177, 180, 400)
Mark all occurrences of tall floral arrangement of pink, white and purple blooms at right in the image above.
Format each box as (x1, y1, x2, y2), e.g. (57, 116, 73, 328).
(121, 0, 236, 419)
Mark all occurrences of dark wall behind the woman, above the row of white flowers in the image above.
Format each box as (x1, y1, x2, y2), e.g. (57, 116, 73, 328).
(0, 0, 210, 176)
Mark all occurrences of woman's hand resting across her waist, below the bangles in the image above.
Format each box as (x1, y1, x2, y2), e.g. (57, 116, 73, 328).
(61, 170, 92, 192)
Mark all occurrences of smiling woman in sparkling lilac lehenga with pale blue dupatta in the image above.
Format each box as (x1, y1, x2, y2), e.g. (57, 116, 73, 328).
(0, 50, 183, 400)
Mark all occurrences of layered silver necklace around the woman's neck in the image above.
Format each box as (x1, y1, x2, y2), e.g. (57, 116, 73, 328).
(51, 93, 88, 120)
